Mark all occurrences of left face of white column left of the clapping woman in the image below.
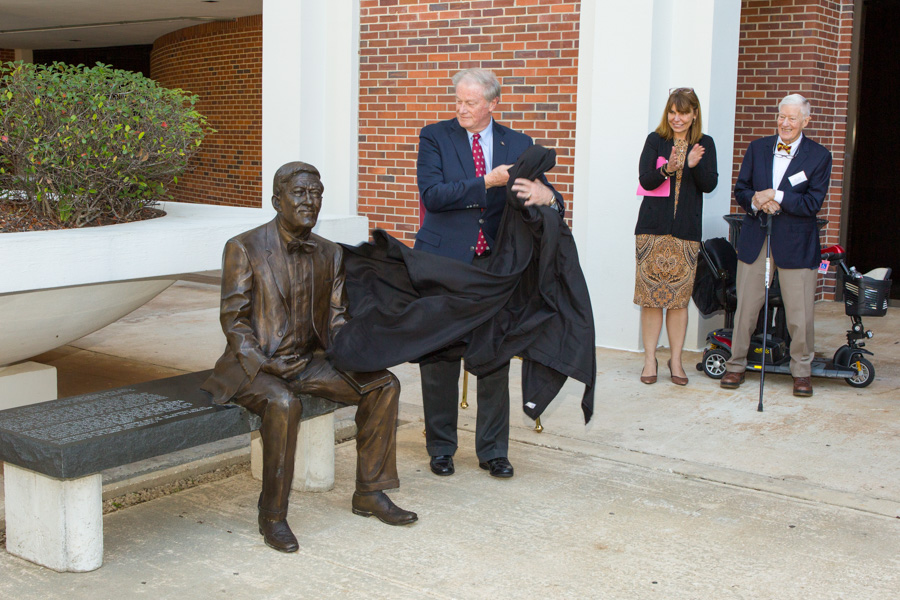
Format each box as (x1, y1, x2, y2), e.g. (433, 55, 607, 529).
(573, 0, 662, 350)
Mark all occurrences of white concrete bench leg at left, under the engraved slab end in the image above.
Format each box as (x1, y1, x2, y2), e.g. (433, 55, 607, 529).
(3, 463, 103, 573)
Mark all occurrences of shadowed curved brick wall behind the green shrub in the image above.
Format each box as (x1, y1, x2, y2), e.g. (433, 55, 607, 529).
(150, 15, 262, 208)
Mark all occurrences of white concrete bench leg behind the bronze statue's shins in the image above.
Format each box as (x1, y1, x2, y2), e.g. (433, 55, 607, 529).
(250, 412, 334, 492)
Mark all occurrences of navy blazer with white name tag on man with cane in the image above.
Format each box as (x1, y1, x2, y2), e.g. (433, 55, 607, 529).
(734, 135, 831, 269)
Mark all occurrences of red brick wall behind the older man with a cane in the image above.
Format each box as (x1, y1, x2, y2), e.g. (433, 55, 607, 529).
(732, 0, 854, 298)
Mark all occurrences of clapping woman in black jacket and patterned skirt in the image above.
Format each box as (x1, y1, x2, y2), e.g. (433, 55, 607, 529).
(634, 88, 719, 385)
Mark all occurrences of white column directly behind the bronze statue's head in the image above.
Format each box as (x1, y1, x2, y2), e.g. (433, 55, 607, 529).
(262, 0, 368, 241)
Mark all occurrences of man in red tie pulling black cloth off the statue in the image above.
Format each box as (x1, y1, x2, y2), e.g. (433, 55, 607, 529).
(415, 69, 565, 477)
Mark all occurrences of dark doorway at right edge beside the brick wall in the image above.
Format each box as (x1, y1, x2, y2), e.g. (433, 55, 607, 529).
(846, 0, 900, 298)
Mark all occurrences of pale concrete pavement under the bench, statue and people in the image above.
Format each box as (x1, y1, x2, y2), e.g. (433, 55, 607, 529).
(0, 277, 900, 600)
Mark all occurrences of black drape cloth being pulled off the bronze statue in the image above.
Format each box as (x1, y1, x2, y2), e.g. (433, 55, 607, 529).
(330, 146, 597, 423)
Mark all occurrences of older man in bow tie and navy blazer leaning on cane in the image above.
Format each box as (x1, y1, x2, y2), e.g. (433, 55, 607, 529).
(720, 94, 831, 396)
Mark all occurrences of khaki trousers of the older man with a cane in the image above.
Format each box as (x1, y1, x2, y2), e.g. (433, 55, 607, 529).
(725, 245, 817, 377)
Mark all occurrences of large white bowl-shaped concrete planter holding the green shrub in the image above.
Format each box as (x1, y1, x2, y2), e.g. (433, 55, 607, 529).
(0, 202, 368, 366)
